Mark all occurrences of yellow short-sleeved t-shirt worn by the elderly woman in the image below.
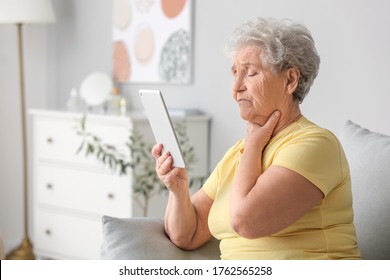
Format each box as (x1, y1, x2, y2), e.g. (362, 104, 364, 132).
(203, 117, 360, 259)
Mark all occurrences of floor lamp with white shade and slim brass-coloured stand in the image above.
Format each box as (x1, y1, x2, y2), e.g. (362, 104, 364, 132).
(0, 0, 55, 260)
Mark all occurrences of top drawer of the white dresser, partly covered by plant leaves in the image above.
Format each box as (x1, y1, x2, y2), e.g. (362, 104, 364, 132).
(33, 118, 130, 166)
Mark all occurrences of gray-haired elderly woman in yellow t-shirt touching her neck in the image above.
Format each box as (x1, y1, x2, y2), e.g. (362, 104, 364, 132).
(152, 18, 360, 259)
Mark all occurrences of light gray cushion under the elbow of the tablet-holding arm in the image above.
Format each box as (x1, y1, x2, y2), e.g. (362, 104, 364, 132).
(101, 216, 220, 260)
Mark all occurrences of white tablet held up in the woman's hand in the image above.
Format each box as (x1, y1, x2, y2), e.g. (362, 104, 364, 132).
(139, 89, 185, 168)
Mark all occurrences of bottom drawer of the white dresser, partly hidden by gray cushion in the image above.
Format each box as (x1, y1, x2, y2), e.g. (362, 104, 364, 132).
(34, 209, 102, 259)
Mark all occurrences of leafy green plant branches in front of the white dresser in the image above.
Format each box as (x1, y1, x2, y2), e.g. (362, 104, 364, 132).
(76, 115, 204, 216)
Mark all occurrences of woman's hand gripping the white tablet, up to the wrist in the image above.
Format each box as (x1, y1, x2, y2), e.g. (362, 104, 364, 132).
(152, 144, 188, 193)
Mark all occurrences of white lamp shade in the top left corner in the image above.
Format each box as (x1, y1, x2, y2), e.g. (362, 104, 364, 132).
(0, 0, 55, 23)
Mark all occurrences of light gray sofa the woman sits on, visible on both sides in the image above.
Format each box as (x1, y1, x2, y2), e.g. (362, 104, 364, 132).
(101, 121, 390, 260)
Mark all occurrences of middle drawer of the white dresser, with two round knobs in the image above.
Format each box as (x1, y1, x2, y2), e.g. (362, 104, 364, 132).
(34, 164, 132, 217)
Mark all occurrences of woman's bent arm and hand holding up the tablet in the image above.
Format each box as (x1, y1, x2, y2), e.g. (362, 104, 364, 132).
(152, 144, 213, 250)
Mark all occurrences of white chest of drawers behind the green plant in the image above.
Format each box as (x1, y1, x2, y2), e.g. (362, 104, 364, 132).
(29, 110, 209, 259)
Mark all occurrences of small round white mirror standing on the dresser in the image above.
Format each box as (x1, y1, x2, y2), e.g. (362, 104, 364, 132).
(80, 72, 113, 106)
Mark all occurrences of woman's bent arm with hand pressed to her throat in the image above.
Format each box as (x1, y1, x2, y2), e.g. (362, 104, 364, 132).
(231, 111, 324, 238)
